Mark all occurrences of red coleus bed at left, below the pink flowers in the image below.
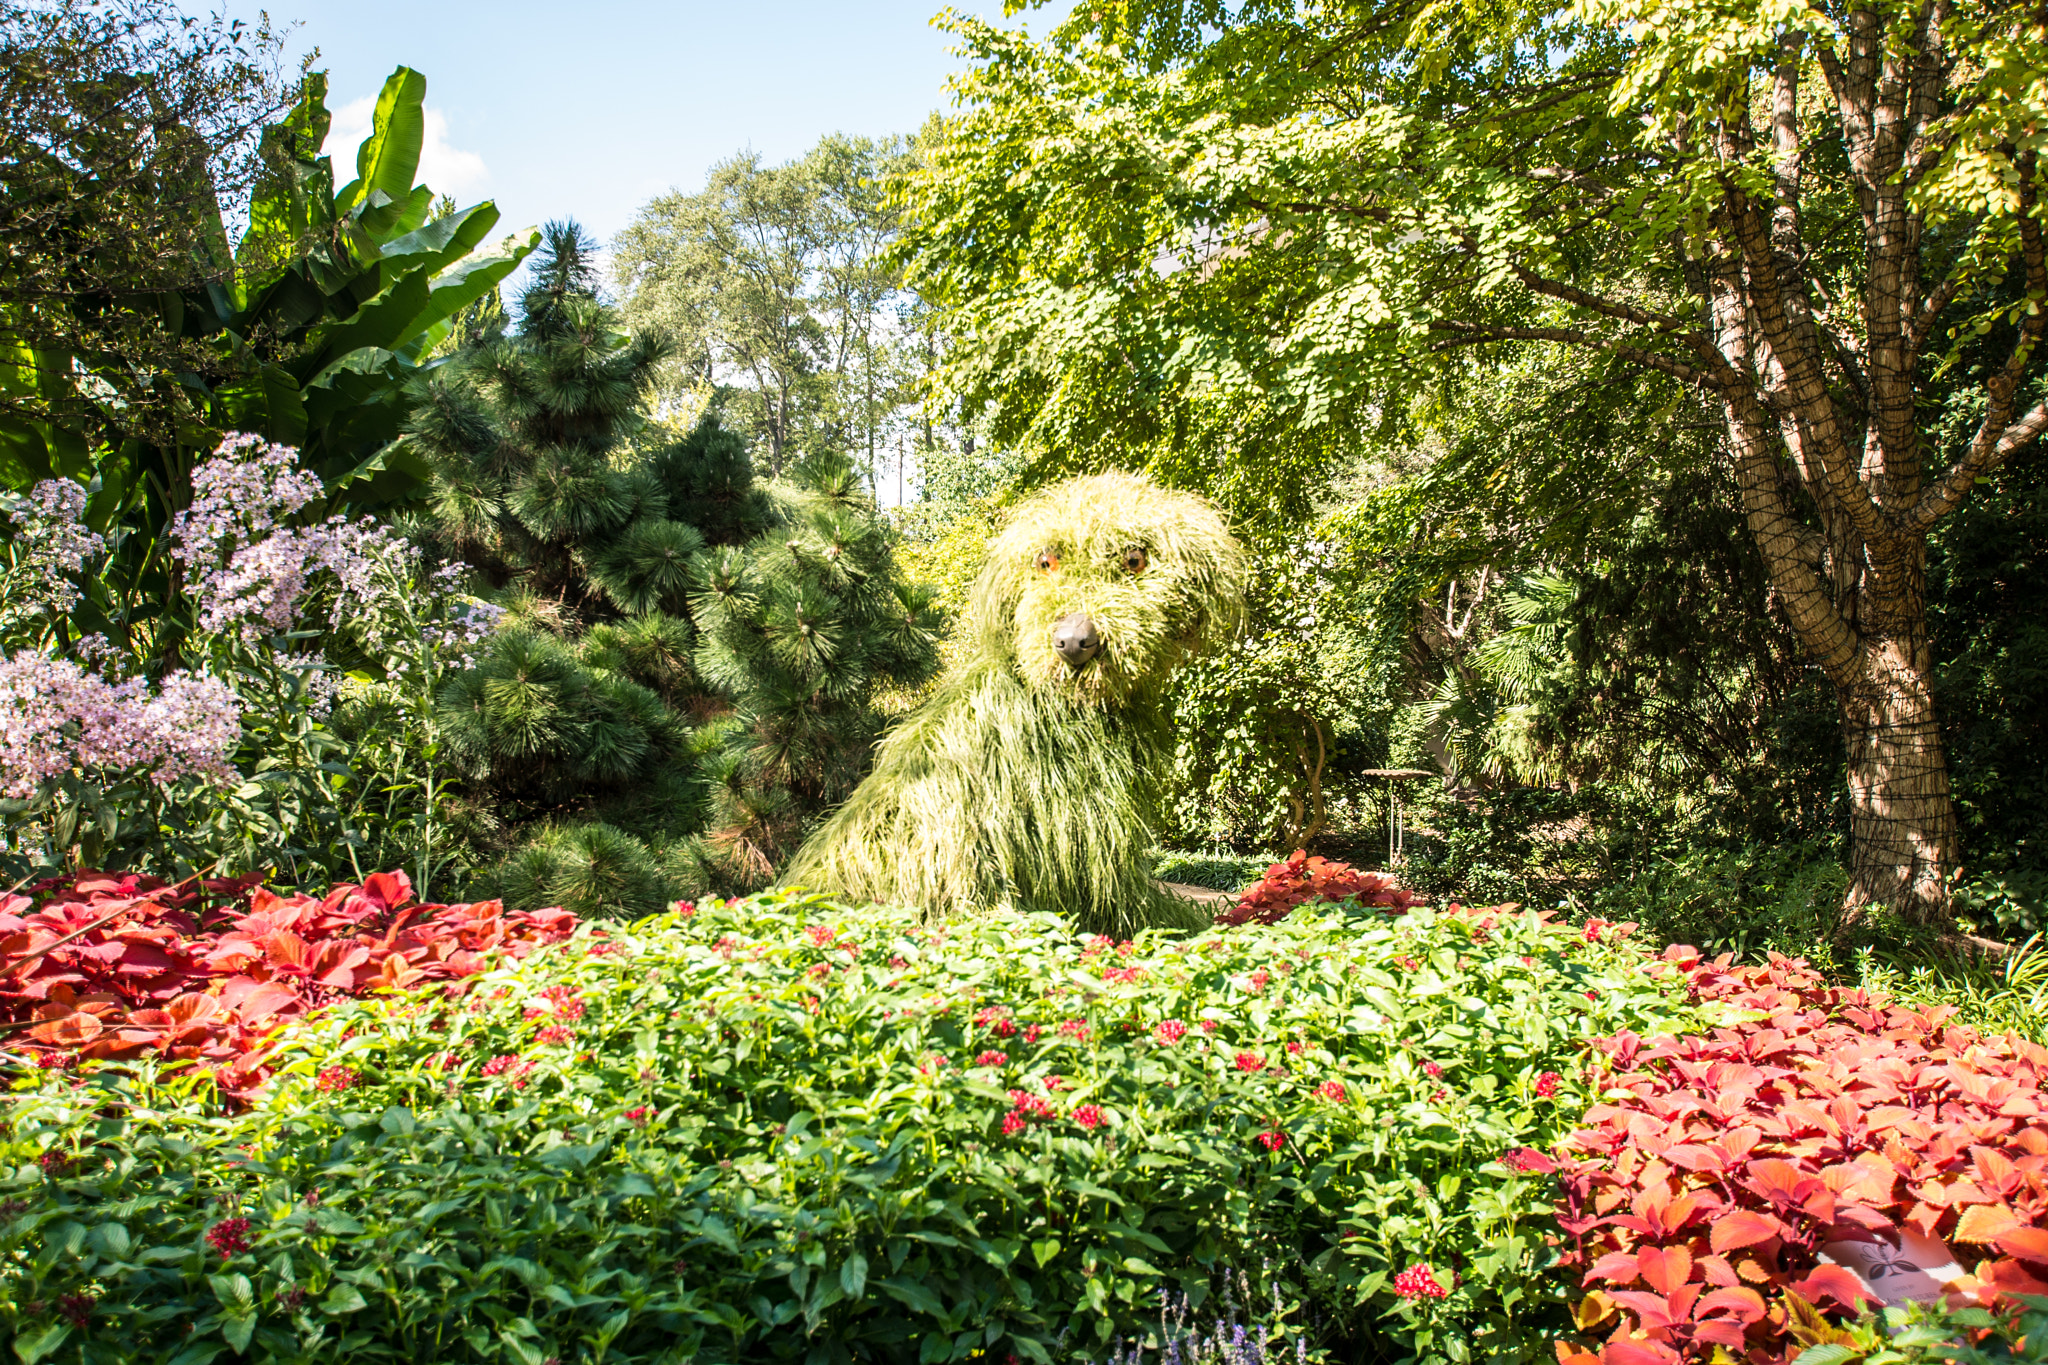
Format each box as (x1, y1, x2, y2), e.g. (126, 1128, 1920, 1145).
(0, 872, 575, 1095)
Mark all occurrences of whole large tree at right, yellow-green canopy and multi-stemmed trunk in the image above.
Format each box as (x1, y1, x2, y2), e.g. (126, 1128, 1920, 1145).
(905, 0, 2048, 919)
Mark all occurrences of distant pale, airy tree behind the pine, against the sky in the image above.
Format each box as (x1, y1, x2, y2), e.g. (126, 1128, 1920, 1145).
(616, 137, 905, 475)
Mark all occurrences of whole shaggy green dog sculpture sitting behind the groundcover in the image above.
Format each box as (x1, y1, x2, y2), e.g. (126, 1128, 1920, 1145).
(782, 475, 1243, 933)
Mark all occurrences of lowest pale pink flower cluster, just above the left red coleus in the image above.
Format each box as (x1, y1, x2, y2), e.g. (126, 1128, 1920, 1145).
(0, 651, 242, 800)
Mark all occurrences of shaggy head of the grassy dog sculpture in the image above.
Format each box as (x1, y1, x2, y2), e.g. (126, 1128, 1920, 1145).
(969, 475, 1245, 706)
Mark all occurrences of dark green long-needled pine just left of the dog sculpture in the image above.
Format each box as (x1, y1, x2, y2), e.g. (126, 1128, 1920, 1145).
(412, 223, 936, 913)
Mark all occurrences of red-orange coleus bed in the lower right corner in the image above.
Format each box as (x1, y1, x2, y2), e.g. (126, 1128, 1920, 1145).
(1559, 948, 2048, 1365)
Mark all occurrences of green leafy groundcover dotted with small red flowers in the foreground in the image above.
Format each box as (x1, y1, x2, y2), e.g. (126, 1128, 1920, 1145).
(0, 894, 1702, 1365)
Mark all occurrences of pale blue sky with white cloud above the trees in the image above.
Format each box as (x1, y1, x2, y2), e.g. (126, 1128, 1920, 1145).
(188, 0, 1040, 239)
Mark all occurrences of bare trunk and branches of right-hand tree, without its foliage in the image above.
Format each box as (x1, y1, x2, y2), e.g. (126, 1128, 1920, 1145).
(1434, 0, 2048, 921)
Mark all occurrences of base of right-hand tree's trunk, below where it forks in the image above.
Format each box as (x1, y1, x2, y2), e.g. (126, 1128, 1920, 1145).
(1837, 630, 1960, 923)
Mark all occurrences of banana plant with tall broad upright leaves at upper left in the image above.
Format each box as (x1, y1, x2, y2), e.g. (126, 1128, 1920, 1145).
(0, 65, 539, 651)
